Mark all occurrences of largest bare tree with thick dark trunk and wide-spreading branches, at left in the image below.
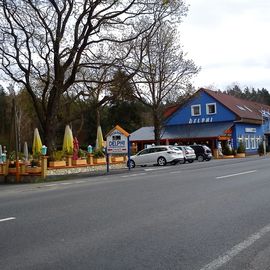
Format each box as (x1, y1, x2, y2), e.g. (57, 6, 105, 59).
(0, 0, 183, 150)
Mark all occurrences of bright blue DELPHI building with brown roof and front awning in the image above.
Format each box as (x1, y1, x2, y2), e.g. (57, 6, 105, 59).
(130, 88, 270, 154)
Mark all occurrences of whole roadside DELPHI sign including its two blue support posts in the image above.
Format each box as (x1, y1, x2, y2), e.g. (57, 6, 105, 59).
(106, 125, 130, 172)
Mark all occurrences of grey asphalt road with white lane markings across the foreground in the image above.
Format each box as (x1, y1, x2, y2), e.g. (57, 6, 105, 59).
(0, 158, 270, 270)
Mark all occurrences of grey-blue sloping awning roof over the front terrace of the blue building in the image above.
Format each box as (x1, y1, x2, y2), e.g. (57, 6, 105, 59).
(130, 122, 233, 141)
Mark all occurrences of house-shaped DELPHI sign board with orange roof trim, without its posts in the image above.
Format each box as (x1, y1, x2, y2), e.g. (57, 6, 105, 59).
(106, 126, 129, 154)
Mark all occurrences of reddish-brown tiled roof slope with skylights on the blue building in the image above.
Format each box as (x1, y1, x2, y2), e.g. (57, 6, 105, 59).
(199, 88, 270, 120)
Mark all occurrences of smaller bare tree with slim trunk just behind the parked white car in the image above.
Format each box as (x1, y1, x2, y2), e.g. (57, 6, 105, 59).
(126, 21, 199, 144)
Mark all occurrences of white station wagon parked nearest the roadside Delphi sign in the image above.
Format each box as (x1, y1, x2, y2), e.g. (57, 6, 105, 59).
(127, 145, 184, 168)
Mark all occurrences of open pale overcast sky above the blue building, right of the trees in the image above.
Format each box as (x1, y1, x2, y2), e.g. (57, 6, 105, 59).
(180, 0, 270, 91)
